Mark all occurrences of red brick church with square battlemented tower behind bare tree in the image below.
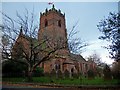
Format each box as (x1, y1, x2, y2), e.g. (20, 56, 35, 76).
(14, 5, 96, 75)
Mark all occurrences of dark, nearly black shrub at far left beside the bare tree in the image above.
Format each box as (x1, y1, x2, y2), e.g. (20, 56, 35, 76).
(2, 60, 27, 77)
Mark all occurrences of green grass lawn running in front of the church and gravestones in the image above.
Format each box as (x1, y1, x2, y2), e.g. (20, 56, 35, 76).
(3, 77, 118, 85)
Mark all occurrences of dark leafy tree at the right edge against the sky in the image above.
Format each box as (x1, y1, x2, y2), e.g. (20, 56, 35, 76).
(98, 12, 120, 61)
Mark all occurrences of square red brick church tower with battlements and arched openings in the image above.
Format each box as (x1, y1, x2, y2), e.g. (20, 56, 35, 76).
(38, 5, 67, 48)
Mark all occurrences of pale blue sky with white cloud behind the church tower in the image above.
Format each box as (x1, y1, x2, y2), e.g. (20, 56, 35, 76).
(2, 2, 118, 64)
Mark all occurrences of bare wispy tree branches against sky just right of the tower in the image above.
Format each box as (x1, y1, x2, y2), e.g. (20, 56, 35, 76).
(67, 22, 89, 54)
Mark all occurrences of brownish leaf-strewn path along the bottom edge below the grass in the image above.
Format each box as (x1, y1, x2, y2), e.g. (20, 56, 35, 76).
(2, 82, 120, 90)
